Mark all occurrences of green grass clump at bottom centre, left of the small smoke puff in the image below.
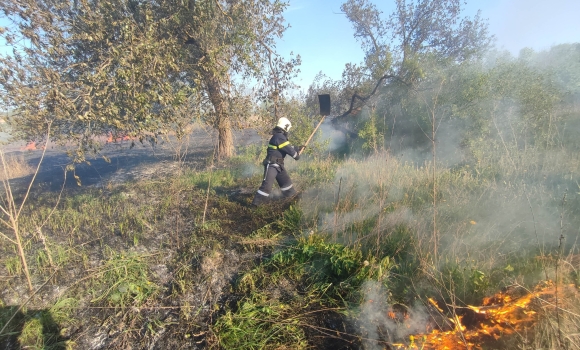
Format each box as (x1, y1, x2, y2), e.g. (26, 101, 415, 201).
(213, 228, 395, 349)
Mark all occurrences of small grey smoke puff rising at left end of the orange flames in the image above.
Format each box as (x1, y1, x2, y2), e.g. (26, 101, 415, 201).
(354, 281, 430, 350)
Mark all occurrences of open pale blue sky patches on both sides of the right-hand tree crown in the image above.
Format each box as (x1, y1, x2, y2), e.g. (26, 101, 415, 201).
(277, 0, 580, 90)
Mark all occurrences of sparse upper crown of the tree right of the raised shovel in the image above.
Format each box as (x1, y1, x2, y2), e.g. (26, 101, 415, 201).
(336, 0, 491, 120)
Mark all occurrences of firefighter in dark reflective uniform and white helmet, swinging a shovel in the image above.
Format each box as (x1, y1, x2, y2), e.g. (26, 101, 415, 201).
(252, 117, 300, 206)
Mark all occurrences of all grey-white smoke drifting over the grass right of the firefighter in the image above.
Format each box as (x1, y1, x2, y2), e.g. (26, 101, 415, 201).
(300, 45, 580, 349)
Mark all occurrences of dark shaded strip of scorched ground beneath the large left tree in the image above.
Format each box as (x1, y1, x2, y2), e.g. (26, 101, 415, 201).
(4, 128, 260, 191)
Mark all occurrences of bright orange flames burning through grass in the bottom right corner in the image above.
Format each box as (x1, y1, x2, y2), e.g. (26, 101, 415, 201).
(386, 281, 580, 349)
